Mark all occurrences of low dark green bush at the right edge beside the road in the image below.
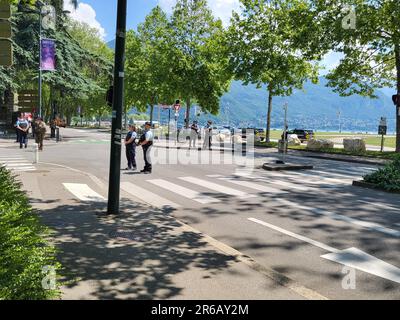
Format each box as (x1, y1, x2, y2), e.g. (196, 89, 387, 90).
(364, 155, 400, 191)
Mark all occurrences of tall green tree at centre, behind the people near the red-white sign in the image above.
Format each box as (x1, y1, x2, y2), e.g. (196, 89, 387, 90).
(169, 0, 231, 127)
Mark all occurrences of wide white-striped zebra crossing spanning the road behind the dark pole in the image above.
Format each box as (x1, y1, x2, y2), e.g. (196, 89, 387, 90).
(63, 165, 376, 209)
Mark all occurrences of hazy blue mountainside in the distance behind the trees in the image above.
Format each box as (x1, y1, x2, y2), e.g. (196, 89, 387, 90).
(142, 78, 395, 132)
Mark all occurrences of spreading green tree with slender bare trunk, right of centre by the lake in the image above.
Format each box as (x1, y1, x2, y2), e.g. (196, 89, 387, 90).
(227, 0, 318, 142)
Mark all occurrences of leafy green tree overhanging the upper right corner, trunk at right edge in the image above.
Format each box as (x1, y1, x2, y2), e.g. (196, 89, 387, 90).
(304, 0, 400, 152)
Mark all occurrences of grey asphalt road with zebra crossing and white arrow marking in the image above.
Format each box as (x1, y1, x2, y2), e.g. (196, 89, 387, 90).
(0, 126, 400, 299)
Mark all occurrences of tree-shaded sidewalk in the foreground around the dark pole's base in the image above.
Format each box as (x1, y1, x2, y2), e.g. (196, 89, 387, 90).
(16, 165, 323, 300)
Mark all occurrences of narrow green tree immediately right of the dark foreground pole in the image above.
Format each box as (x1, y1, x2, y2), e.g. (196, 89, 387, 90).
(125, 6, 174, 125)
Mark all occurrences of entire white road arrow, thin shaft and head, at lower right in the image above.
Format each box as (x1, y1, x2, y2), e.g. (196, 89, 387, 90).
(248, 218, 400, 283)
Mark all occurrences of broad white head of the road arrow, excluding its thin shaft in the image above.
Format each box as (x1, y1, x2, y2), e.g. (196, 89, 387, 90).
(321, 248, 400, 283)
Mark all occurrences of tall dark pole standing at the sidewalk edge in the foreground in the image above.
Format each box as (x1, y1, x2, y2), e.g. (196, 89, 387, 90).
(107, 0, 127, 214)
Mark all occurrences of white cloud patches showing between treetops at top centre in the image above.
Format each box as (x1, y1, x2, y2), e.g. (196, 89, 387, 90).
(158, 0, 241, 26)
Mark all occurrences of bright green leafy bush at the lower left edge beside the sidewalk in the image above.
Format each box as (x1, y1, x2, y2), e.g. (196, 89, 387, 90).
(0, 167, 60, 300)
